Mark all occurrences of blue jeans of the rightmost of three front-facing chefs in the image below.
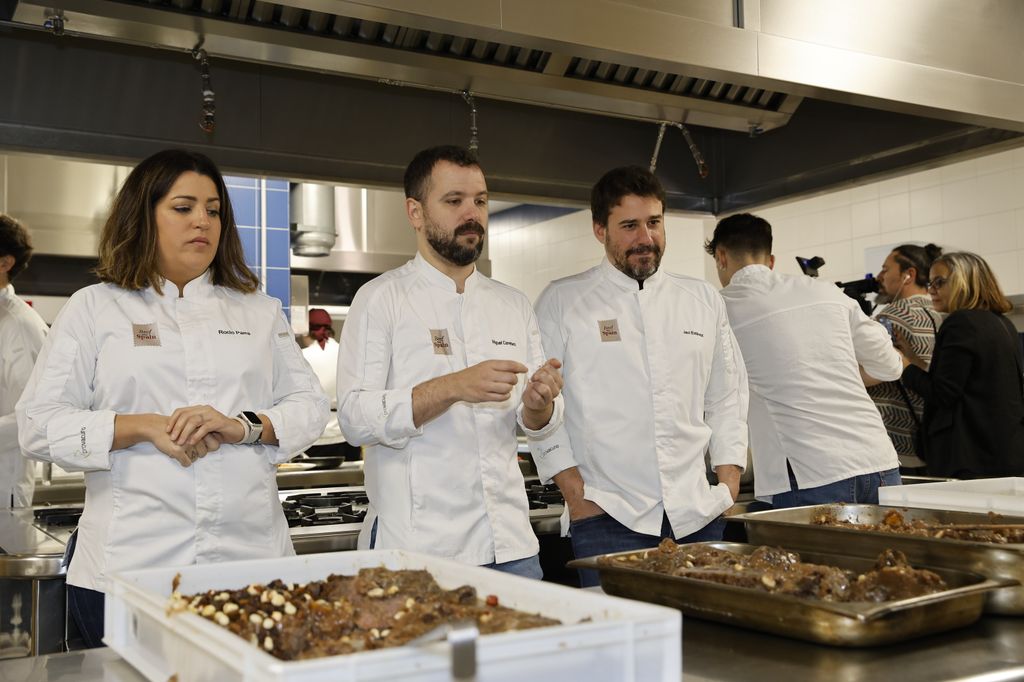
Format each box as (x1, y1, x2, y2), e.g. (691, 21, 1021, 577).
(569, 514, 725, 587)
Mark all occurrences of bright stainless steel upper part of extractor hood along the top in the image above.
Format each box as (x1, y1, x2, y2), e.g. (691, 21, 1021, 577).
(11, 0, 1024, 132)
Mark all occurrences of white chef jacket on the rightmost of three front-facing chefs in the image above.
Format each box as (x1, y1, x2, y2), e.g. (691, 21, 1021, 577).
(529, 259, 748, 538)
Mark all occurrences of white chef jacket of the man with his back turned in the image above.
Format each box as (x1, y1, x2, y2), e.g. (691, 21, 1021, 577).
(722, 265, 903, 500)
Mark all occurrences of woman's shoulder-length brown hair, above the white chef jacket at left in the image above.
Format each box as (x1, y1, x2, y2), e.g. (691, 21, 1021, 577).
(95, 150, 259, 293)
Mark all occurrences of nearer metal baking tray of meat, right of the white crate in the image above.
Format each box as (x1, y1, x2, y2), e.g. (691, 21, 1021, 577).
(568, 542, 1017, 647)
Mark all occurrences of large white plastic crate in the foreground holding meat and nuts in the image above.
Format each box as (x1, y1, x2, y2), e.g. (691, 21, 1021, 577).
(103, 550, 682, 682)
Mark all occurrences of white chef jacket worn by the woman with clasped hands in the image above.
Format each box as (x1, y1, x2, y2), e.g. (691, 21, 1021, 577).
(17, 273, 329, 591)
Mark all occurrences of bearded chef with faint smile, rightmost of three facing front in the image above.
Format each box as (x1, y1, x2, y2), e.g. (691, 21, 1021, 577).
(530, 166, 746, 586)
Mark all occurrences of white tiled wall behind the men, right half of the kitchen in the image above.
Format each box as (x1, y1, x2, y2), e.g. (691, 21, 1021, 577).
(489, 144, 1024, 300)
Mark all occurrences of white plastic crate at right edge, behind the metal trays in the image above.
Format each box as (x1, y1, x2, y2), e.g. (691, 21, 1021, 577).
(879, 478, 1024, 516)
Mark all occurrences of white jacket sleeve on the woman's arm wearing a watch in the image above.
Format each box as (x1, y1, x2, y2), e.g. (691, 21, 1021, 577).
(260, 309, 331, 463)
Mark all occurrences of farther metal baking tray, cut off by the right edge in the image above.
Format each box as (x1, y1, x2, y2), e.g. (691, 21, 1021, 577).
(728, 505, 1024, 615)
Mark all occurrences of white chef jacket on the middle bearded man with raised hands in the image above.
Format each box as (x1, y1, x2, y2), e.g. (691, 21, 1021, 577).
(338, 254, 561, 565)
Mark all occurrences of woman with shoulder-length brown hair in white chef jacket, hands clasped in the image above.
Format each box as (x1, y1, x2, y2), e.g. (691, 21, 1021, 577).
(16, 150, 329, 646)
